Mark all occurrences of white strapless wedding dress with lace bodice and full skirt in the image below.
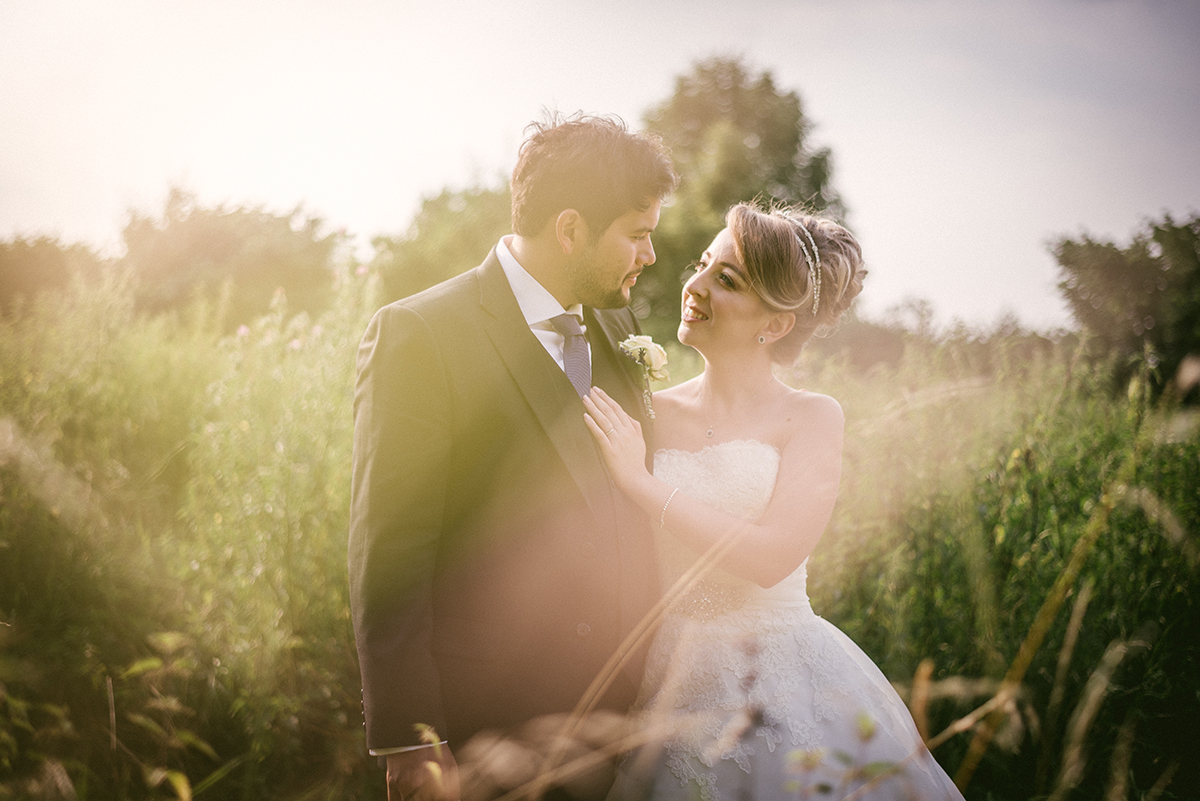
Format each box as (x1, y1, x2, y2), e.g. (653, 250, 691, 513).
(610, 440, 962, 801)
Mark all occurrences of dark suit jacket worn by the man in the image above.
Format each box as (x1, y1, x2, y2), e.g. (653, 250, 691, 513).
(349, 252, 658, 748)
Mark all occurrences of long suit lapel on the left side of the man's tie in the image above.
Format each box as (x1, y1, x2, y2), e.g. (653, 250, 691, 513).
(479, 252, 616, 528)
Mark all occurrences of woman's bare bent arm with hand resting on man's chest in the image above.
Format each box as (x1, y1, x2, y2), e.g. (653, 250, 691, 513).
(584, 390, 845, 586)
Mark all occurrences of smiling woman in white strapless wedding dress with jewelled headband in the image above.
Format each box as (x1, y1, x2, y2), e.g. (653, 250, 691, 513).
(584, 204, 962, 801)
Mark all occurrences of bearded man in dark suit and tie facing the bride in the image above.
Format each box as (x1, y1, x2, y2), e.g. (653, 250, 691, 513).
(349, 116, 678, 799)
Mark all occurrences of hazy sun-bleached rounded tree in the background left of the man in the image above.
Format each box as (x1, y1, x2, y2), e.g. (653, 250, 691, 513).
(124, 187, 342, 329)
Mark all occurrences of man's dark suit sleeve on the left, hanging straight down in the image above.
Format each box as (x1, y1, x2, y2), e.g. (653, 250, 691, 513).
(349, 306, 451, 749)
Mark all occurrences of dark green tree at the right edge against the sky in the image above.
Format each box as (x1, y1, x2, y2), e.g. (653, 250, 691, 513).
(1054, 216, 1200, 398)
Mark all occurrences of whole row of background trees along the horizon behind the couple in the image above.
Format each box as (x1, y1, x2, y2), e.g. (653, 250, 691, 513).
(0, 58, 1200, 389)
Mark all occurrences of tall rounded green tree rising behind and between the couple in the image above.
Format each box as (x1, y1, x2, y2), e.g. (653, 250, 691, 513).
(635, 58, 844, 338)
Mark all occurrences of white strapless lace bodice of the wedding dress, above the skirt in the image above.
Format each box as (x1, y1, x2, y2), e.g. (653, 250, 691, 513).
(654, 440, 809, 619)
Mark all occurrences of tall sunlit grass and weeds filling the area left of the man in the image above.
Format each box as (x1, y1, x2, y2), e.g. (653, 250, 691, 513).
(0, 256, 377, 799)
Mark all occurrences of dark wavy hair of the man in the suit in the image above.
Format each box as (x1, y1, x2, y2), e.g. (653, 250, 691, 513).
(511, 114, 679, 241)
